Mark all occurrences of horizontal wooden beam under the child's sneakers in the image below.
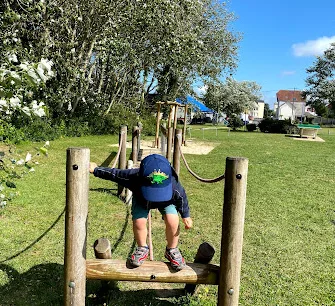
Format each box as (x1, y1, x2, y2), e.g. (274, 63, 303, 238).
(86, 259, 220, 285)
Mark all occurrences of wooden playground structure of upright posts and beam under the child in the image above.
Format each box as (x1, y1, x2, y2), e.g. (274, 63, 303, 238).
(64, 123, 248, 306)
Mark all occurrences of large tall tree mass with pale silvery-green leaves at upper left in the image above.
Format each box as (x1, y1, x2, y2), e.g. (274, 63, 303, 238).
(0, 0, 239, 119)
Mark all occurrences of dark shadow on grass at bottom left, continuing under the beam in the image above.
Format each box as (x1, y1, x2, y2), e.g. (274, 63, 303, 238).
(0, 263, 180, 306)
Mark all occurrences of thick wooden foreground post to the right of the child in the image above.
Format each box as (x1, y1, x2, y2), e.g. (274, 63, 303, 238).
(218, 157, 248, 306)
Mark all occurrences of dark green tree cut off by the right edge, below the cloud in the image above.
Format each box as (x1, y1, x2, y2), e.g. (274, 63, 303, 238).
(303, 43, 335, 116)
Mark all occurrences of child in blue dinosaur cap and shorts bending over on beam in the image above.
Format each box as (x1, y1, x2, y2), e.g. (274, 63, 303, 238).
(90, 154, 193, 271)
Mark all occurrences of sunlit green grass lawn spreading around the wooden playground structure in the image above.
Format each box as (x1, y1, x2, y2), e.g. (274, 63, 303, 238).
(0, 126, 335, 306)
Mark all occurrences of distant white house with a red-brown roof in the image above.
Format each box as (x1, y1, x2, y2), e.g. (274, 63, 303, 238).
(274, 90, 316, 121)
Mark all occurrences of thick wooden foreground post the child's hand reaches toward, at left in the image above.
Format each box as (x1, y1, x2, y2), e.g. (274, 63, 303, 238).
(64, 148, 90, 306)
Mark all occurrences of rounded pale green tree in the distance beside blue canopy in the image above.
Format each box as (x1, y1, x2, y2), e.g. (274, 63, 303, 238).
(204, 78, 261, 117)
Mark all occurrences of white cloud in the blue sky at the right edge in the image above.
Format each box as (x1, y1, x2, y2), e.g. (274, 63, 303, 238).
(292, 36, 335, 57)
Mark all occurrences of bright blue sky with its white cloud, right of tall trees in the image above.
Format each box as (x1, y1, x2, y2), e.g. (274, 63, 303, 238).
(194, 0, 335, 109)
